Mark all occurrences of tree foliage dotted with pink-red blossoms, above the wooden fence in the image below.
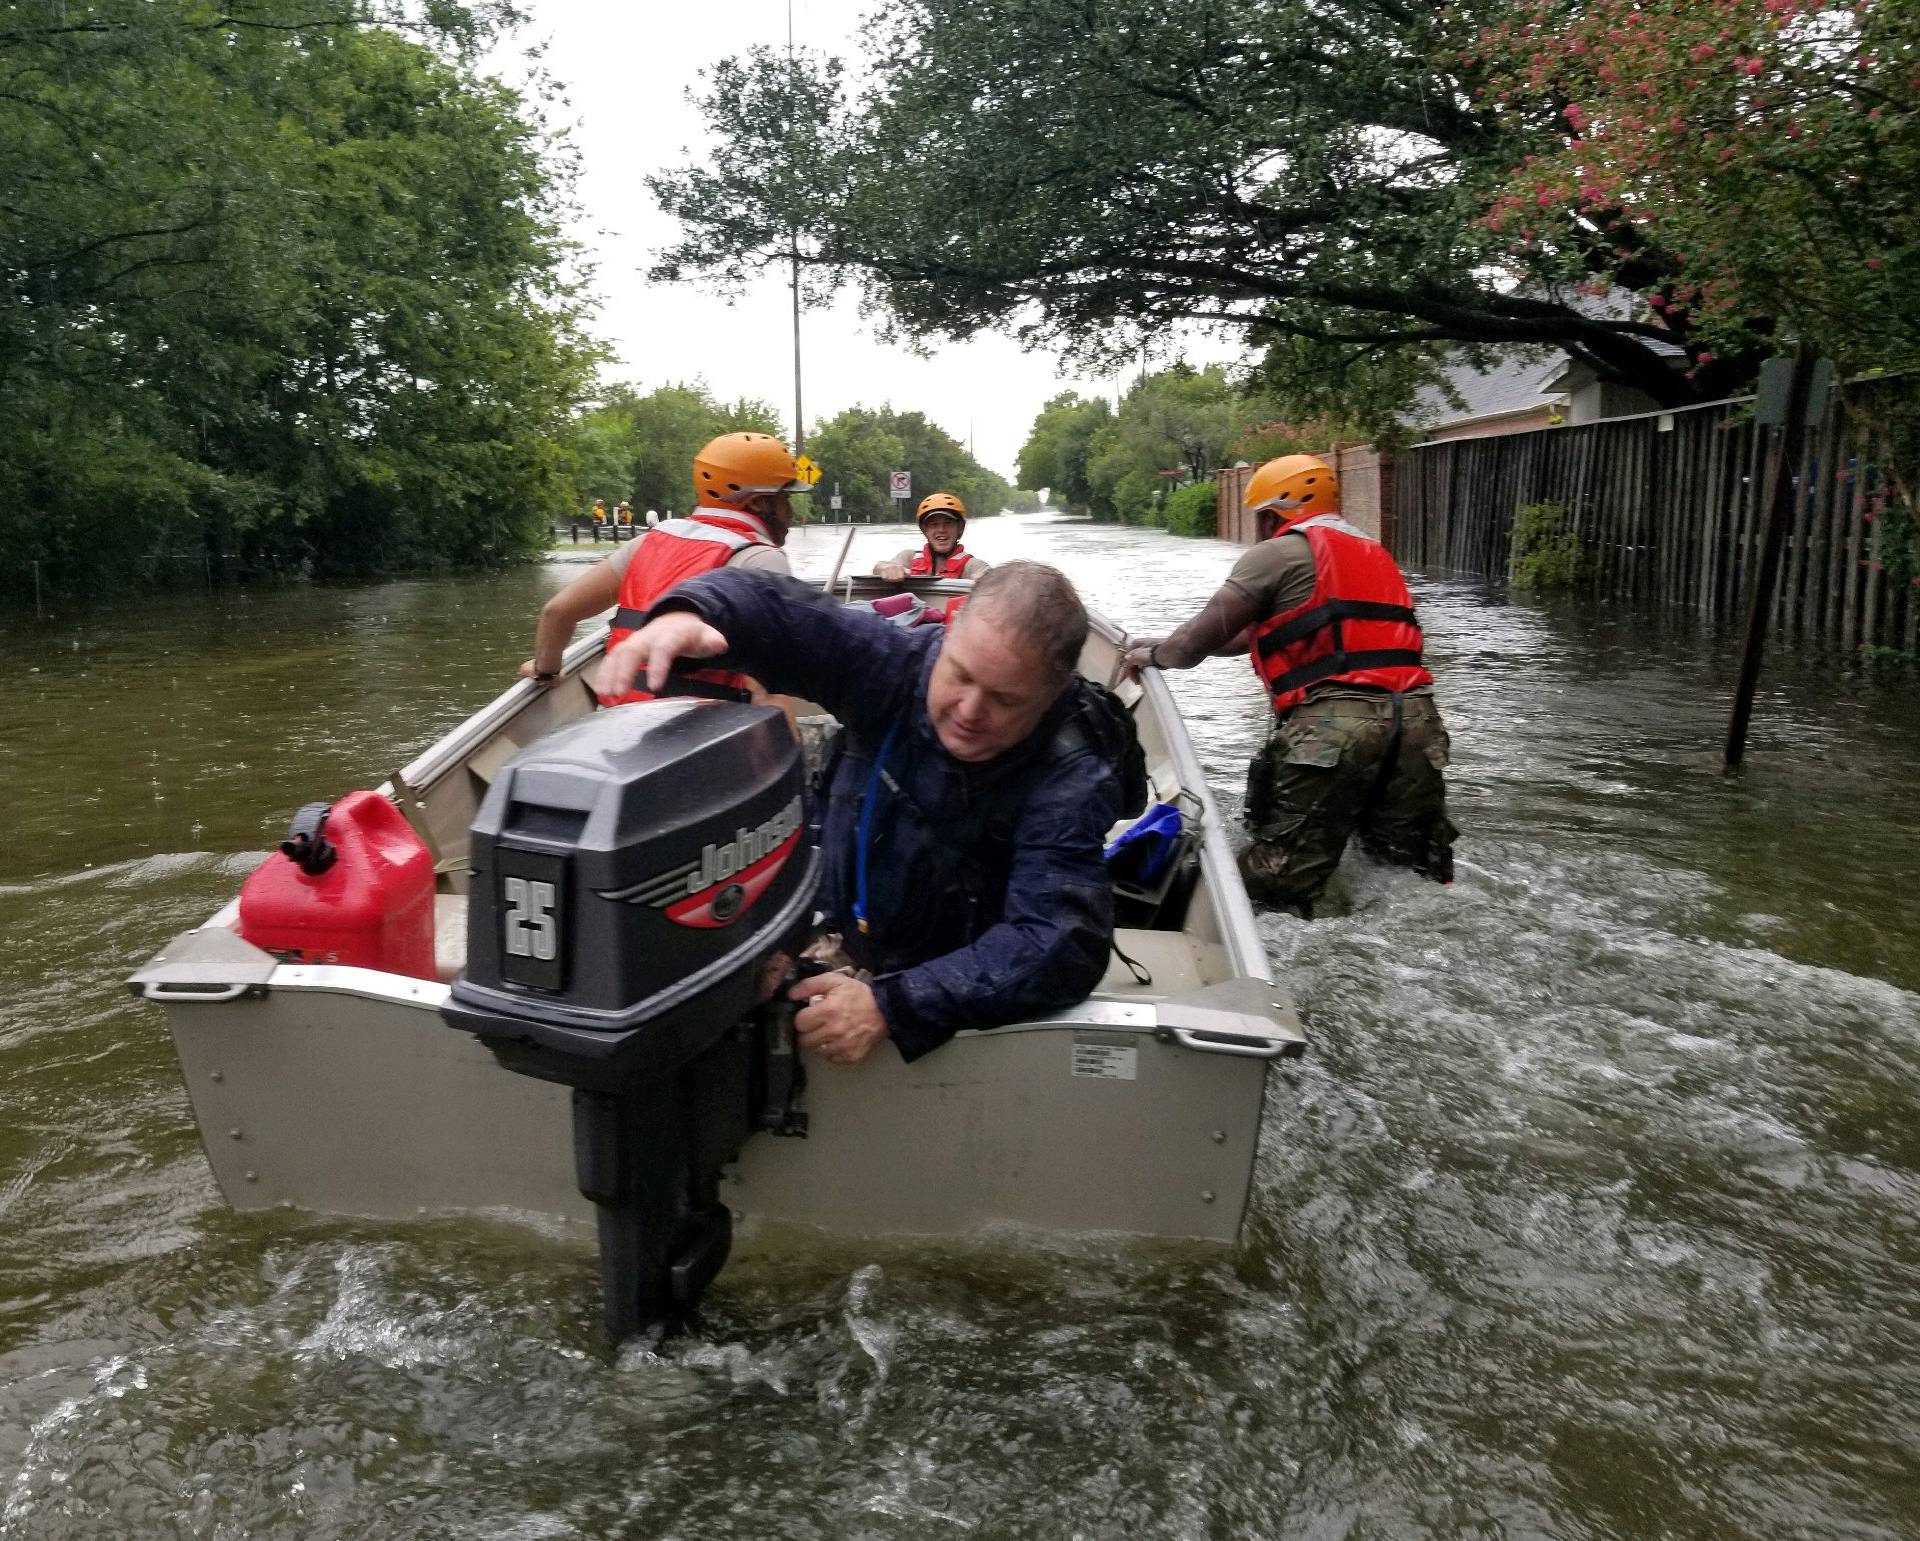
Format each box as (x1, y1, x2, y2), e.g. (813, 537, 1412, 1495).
(1469, 0, 1920, 372)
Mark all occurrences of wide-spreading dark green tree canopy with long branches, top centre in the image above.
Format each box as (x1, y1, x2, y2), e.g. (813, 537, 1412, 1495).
(655, 0, 1781, 422)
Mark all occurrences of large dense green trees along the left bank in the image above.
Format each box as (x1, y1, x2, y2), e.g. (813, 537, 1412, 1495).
(0, 0, 595, 593)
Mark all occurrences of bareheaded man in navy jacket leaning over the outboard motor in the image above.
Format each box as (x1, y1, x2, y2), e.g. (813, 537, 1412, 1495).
(599, 562, 1146, 1063)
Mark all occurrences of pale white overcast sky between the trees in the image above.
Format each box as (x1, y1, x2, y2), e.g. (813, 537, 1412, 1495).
(478, 0, 1225, 480)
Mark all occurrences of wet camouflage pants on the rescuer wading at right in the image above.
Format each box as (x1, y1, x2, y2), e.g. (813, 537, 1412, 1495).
(1240, 695, 1459, 915)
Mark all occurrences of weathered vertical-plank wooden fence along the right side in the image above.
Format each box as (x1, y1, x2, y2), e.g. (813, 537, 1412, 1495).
(1388, 374, 1920, 652)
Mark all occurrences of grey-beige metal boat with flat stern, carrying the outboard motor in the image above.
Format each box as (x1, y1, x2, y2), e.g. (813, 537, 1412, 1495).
(131, 578, 1304, 1336)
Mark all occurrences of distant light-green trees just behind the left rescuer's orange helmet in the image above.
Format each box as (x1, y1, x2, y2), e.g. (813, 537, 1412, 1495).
(572, 384, 785, 514)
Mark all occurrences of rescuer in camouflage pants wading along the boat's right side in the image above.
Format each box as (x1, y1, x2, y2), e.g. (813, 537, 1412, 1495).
(1127, 455, 1457, 915)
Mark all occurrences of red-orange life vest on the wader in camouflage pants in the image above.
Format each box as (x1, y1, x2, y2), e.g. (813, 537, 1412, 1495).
(1252, 514, 1434, 712)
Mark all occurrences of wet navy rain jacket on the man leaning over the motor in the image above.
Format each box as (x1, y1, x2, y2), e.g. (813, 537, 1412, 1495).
(653, 570, 1125, 1059)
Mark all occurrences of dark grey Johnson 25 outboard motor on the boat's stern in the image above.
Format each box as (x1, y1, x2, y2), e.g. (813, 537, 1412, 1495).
(442, 700, 820, 1341)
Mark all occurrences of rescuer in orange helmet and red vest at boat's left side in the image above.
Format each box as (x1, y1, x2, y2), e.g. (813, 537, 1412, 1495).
(520, 434, 820, 706)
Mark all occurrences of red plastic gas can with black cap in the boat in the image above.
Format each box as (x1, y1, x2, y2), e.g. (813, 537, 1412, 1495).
(240, 793, 434, 979)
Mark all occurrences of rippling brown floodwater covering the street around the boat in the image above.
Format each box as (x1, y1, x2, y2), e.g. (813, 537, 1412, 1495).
(0, 518, 1920, 1541)
